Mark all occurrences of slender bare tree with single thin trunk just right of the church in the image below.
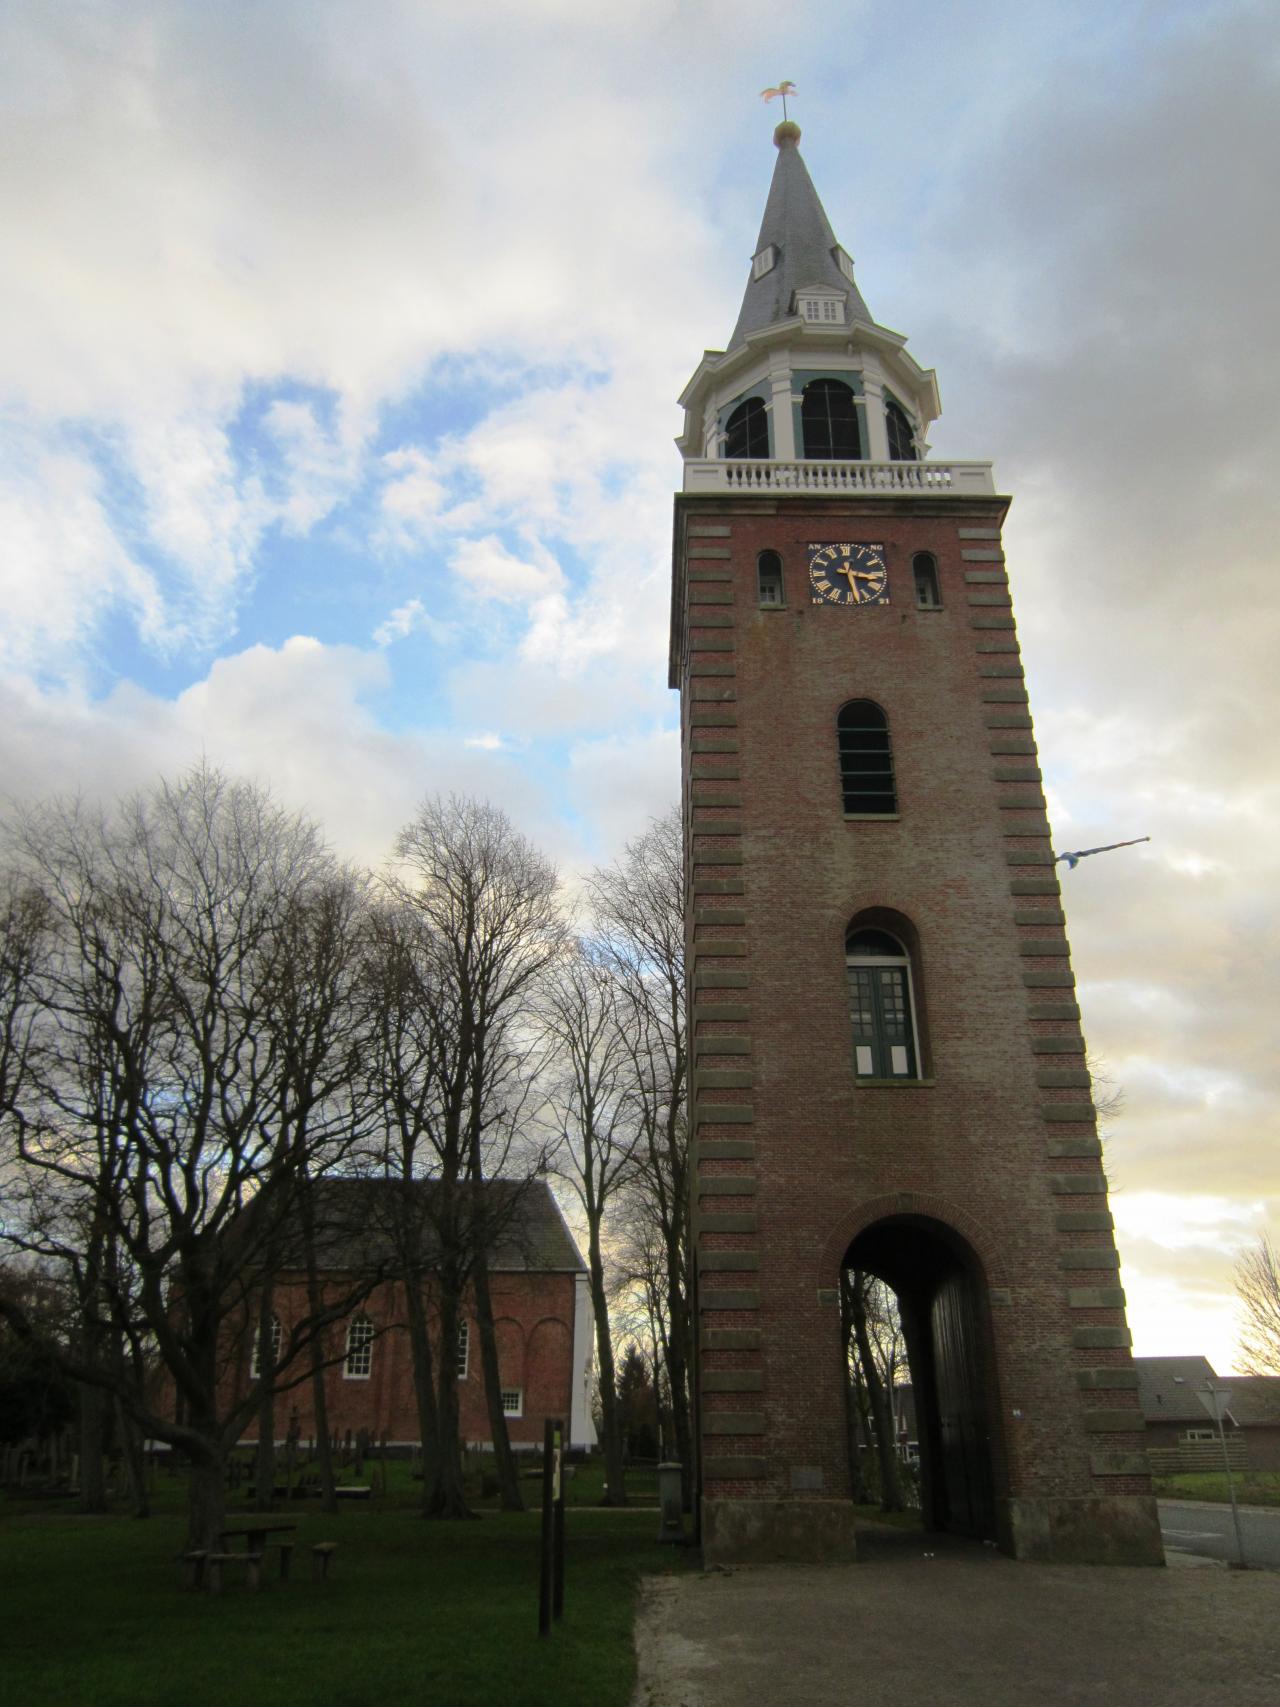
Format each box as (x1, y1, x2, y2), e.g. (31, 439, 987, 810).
(544, 944, 642, 1506)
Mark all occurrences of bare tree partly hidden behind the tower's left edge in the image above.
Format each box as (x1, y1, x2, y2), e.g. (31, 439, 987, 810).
(587, 807, 693, 1504)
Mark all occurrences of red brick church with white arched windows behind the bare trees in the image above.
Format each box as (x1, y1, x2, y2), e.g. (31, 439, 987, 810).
(225, 1180, 596, 1449)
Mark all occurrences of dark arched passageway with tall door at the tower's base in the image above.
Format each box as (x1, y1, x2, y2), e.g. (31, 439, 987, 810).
(841, 1215, 998, 1540)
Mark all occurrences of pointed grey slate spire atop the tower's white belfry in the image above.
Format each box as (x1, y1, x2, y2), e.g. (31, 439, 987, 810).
(727, 121, 870, 350)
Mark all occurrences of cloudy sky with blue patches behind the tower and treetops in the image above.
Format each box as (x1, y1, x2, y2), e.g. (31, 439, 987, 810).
(0, 0, 1280, 1371)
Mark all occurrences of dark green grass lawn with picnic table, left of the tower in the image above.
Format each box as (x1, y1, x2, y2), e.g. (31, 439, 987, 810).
(0, 1478, 686, 1707)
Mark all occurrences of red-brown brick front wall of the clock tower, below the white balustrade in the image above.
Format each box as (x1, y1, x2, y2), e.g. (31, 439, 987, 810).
(672, 497, 1149, 1536)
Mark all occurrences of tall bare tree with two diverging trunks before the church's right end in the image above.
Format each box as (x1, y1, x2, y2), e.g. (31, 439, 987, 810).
(396, 797, 567, 1516)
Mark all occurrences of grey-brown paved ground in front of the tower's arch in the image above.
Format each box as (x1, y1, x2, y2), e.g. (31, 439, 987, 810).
(635, 1536, 1280, 1707)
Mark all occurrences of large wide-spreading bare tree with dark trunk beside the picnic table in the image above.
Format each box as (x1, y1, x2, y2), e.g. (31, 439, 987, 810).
(0, 766, 375, 1547)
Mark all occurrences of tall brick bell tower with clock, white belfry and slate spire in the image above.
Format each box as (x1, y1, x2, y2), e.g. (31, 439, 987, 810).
(671, 123, 1164, 1564)
